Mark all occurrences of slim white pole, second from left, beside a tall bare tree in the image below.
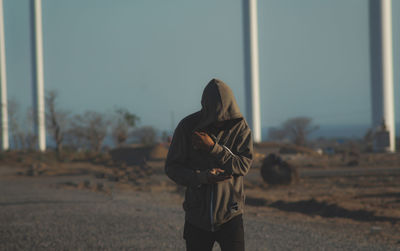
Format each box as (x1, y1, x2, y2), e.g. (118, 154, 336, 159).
(32, 0, 46, 152)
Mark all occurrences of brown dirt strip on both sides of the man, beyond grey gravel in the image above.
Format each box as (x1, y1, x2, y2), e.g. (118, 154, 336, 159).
(0, 149, 400, 249)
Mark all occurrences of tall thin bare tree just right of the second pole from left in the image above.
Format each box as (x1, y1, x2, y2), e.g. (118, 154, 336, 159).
(46, 90, 69, 154)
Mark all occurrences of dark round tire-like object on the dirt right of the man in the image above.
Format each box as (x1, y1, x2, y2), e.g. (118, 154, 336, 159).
(261, 154, 299, 185)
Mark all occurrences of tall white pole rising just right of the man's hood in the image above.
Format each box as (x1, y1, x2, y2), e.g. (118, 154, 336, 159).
(243, 0, 261, 142)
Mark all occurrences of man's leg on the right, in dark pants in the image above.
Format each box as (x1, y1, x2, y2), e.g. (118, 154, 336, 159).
(216, 215, 244, 251)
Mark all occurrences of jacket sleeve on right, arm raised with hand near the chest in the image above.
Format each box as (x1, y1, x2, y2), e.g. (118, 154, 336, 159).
(211, 125, 253, 176)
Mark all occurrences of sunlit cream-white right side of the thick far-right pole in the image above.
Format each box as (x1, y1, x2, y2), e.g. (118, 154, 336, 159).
(381, 0, 396, 152)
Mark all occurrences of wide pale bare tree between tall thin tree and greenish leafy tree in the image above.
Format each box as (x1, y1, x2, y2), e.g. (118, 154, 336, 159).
(68, 111, 110, 152)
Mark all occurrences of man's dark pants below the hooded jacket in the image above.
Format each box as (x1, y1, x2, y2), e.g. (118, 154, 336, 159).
(183, 215, 244, 251)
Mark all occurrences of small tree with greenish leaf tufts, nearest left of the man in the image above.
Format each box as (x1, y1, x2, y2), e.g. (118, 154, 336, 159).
(112, 108, 140, 146)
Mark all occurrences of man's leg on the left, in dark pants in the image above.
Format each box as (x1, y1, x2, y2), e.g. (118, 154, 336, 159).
(183, 222, 215, 251)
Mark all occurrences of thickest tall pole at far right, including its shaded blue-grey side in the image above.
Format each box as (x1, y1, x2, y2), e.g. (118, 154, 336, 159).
(369, 0, 396, 152)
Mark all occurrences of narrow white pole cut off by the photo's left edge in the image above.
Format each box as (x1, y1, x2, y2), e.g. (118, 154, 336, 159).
(0, 0, 9, 150)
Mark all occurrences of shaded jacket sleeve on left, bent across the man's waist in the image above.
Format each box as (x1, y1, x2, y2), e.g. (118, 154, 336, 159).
(165, 122, 207, 186)
